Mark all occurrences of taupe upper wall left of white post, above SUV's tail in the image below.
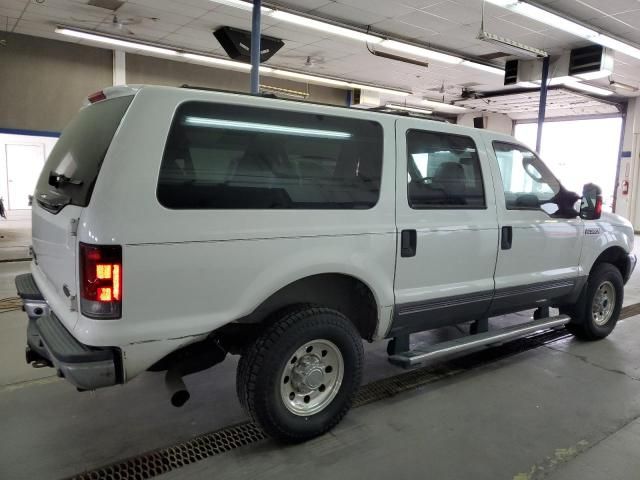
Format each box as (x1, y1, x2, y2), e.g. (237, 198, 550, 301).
(0, 34, 113, 132)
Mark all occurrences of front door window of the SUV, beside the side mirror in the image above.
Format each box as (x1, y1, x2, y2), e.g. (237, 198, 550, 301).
(493, 142, 561, 210)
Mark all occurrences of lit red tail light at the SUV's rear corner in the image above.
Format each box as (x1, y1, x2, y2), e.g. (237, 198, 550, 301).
(80, 243, 122, 319)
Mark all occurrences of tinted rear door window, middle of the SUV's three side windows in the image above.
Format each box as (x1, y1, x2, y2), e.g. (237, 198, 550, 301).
(407, 130, 486, 209)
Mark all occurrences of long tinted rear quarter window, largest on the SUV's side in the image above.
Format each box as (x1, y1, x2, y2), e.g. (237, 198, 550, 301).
(158, 102, 382, 209)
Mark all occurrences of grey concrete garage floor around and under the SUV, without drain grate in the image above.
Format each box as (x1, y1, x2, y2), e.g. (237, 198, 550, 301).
(0, 227, 640, 480)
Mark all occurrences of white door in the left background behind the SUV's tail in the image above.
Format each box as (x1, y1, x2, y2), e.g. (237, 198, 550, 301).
(5, 144, 45, 210)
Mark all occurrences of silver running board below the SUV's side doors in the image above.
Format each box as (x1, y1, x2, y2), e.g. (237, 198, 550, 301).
(389, 315, 571, 368)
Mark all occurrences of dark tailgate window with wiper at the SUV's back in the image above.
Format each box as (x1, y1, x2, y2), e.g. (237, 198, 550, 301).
(36, 95, 133, 212)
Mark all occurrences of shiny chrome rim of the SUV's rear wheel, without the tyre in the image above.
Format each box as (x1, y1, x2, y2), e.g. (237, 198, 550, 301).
(280, 340, 344, 416)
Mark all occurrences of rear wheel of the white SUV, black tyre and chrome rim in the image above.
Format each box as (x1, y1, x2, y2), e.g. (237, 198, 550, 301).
(236, 306, 364, 442)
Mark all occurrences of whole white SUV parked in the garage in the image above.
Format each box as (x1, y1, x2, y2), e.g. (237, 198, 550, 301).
(16, 86, 635, 441)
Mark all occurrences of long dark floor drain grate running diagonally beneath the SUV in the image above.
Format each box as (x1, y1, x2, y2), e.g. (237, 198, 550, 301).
(65, 304, 640, 480)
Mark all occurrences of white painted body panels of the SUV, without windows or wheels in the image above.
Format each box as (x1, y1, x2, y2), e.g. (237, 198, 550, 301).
(27, 87, 632, 380)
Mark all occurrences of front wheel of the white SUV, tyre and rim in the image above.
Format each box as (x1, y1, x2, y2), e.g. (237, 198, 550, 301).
(561, 263, 624, 340)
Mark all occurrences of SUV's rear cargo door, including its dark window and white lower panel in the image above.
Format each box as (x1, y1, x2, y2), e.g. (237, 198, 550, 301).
(32, 95, 133, 328)
